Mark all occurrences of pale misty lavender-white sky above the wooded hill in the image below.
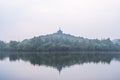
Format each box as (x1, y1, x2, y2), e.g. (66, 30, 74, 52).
(0, 0, 120, 41)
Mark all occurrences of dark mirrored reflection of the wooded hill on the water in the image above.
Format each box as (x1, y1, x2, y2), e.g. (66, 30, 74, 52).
(0, 52, 120, 71)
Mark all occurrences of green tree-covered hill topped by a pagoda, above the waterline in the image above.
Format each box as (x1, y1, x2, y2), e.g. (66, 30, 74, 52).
(0, 30, 120, 51)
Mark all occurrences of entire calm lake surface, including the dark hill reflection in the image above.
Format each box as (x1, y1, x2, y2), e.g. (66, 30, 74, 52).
(0, 52, 120, 80)
